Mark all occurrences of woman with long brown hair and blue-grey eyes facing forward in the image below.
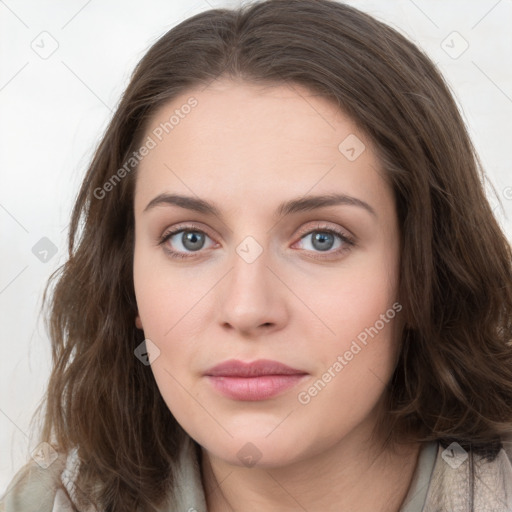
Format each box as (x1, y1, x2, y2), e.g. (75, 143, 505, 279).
(3, 0, 512, 512)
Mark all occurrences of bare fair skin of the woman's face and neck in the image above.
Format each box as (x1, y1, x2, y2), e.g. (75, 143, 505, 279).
(134, 79, 419, 512)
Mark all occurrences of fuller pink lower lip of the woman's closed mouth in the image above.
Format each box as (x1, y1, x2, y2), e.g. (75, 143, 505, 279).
(208, 374, 306, 401)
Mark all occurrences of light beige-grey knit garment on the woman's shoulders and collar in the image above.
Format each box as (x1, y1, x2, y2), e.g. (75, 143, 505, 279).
(0, 437, 512, 512)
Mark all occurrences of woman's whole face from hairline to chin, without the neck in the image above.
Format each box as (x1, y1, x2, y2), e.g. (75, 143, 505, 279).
(134, 80, 401, 467)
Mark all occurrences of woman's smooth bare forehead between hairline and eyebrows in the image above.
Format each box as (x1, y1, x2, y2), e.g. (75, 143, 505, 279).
(132, 80, 383, 216)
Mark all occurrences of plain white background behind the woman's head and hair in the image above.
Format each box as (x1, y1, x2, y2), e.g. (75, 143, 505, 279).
(0, 0, 512, 493)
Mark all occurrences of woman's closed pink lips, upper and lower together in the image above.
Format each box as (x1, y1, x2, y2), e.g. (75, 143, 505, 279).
(204, 359, 308, 401)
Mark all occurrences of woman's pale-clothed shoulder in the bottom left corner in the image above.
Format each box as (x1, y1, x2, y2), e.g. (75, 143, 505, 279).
(0, 453, 74, 512)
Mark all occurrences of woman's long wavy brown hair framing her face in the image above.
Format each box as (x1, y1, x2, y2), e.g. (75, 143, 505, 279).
(4, 0, 512, 511)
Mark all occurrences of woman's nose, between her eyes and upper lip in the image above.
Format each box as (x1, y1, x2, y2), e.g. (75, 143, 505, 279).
(217, 242, 290, 337)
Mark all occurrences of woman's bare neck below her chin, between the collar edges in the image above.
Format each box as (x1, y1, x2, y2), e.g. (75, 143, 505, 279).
(201, 432, 420, 512)
